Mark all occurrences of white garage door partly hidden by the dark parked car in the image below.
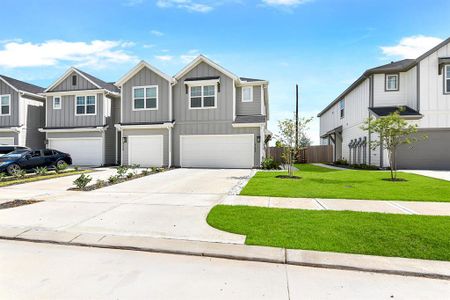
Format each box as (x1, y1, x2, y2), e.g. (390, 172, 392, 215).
(48, 138, 103, 166)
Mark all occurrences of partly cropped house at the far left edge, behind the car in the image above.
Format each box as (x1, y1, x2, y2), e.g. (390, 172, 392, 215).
(0, 75, 45, 148)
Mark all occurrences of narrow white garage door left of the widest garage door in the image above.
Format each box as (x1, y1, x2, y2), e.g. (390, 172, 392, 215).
(128, 135, 164, 167)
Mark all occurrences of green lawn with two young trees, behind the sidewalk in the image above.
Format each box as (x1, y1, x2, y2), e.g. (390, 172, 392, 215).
(241, 165, 450, 202)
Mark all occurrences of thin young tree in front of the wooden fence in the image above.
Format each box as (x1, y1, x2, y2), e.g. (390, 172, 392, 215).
(277, 114, 312, 177)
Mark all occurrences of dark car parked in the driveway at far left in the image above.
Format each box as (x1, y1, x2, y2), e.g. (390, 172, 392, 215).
(0, 149, 72, 175)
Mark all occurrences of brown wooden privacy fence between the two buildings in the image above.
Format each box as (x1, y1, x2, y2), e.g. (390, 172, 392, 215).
(269, 145, 333, 163)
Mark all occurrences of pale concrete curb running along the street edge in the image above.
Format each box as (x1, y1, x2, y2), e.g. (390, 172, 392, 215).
(0, 227, 450, 280)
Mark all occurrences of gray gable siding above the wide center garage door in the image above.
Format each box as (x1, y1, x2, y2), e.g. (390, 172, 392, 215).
(173, 63, 234, 122)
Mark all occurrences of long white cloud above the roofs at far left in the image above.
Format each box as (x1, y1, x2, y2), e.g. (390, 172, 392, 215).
(0, 40, 136, 68)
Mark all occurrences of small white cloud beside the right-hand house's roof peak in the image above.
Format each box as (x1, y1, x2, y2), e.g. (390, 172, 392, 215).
(381, 35, 443, 59)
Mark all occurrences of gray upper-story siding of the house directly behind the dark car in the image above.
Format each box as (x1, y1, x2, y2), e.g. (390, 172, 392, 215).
(46, 93, 104, 127)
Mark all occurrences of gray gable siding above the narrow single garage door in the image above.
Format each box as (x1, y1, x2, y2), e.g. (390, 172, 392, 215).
(122, 67, 169, 123)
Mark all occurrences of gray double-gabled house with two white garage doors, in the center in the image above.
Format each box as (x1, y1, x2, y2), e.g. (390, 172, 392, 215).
(116, 55, 268, 168)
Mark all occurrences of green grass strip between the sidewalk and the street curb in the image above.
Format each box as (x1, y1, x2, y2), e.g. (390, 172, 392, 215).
(207, 205, 450, 261)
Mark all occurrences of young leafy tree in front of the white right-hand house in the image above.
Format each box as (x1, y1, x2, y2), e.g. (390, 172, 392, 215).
(361, 108, 426, 181)
